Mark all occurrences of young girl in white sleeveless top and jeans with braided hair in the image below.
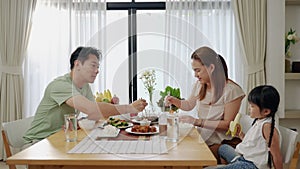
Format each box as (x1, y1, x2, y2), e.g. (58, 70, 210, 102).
(218, 85, 283, 169)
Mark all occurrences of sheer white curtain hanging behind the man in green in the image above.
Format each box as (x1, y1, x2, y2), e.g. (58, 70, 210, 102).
(24, 0, 106, 116)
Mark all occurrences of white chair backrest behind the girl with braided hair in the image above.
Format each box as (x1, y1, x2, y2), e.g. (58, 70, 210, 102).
(279, 126, 298, 163)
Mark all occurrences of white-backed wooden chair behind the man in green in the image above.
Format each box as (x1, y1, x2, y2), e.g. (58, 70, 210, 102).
(2, 116, 33, 169)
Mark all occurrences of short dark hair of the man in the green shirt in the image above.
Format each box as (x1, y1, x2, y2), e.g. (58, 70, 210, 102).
(70, 46, 101, 70)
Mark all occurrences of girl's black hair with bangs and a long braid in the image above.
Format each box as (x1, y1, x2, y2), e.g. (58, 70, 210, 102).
(248, 85, 280, 168)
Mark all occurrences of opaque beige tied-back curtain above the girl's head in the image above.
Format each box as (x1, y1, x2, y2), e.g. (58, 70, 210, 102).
(233, 0, 267, 92)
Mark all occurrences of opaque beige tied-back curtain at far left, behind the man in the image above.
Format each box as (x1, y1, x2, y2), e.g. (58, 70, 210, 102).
(0, 0, 36, 159)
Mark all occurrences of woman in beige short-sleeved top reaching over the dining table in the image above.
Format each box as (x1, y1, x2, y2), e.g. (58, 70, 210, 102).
(166, 47, 245, 163)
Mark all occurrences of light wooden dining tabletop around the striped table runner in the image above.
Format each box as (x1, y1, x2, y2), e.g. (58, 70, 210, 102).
(6, 125, 217, 169)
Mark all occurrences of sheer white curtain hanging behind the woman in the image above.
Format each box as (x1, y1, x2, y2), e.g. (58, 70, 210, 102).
(164, 0, 245, 107)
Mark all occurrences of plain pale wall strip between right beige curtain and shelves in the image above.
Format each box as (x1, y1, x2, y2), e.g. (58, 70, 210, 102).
(266, 0, 285, 118)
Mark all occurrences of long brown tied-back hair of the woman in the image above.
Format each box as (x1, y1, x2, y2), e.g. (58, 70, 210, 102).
(191, 46, 228, 103)
